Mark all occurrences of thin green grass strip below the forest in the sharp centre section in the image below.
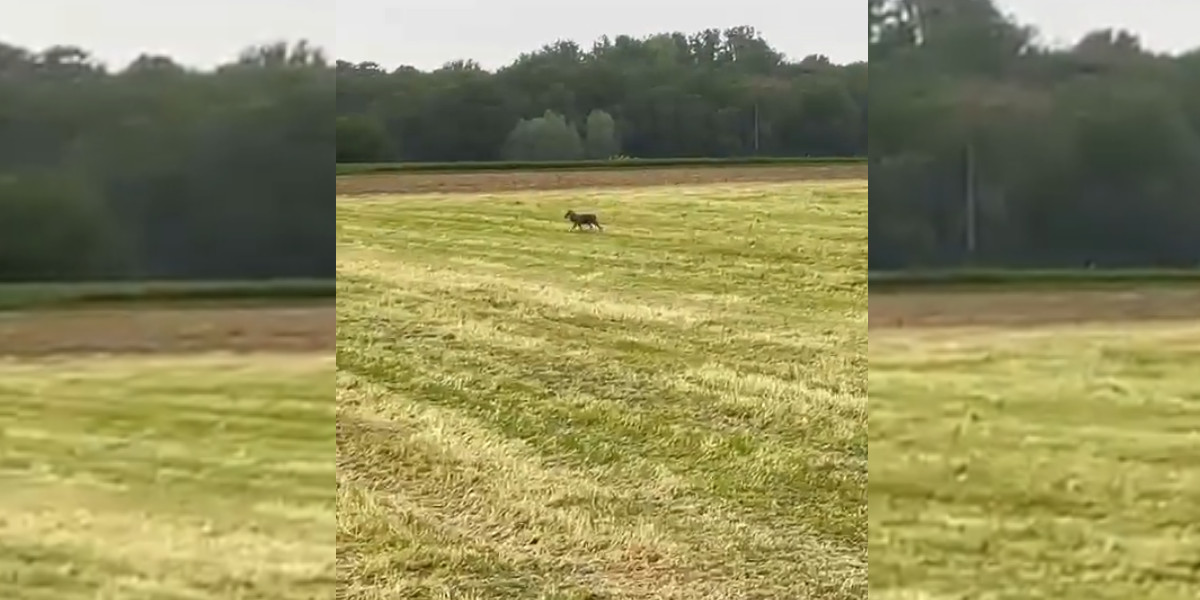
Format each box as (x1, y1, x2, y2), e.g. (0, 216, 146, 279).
(336, 156, 866, 175)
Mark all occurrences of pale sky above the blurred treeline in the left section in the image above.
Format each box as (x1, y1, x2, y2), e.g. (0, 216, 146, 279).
(0, 0, 336, 68)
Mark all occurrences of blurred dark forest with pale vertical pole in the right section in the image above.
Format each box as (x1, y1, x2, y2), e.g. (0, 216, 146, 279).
(869, 0, 1200, 269)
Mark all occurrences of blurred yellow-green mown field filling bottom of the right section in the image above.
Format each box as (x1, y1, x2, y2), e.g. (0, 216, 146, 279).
(870, 316, 1200, 600)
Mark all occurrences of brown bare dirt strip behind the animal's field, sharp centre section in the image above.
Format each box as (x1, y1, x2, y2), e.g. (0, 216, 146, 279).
(337, 164, 866, 196)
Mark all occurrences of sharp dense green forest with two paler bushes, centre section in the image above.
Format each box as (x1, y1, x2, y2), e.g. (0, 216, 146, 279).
(337, 26, 868, 162)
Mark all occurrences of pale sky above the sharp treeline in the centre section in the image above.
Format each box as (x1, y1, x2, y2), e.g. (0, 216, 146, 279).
(332, 0, 868, 70)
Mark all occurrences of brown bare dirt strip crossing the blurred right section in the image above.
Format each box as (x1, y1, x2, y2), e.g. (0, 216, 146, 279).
(870, 288, 1200, 329)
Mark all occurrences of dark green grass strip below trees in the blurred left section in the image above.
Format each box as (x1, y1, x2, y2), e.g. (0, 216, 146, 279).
(0, 280, 337, 311)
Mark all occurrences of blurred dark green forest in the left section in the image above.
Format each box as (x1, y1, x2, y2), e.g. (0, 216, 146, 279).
(0, 43, 335, 281)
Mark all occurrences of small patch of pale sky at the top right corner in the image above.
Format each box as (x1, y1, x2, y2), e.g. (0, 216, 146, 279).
(996, 0, 1200, 53)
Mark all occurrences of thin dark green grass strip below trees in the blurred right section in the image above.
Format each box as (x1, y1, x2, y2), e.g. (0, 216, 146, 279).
(870, 269, 1200, 293)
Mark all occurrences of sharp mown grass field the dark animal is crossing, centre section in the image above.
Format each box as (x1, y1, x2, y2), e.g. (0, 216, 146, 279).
(337, 175, 868, 600)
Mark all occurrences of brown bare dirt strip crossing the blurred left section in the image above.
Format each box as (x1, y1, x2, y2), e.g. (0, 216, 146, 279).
(0, 304, 336, 356)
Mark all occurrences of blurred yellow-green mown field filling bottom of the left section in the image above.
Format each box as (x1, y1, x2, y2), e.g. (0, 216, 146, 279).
(0, 354, 335, 600)
